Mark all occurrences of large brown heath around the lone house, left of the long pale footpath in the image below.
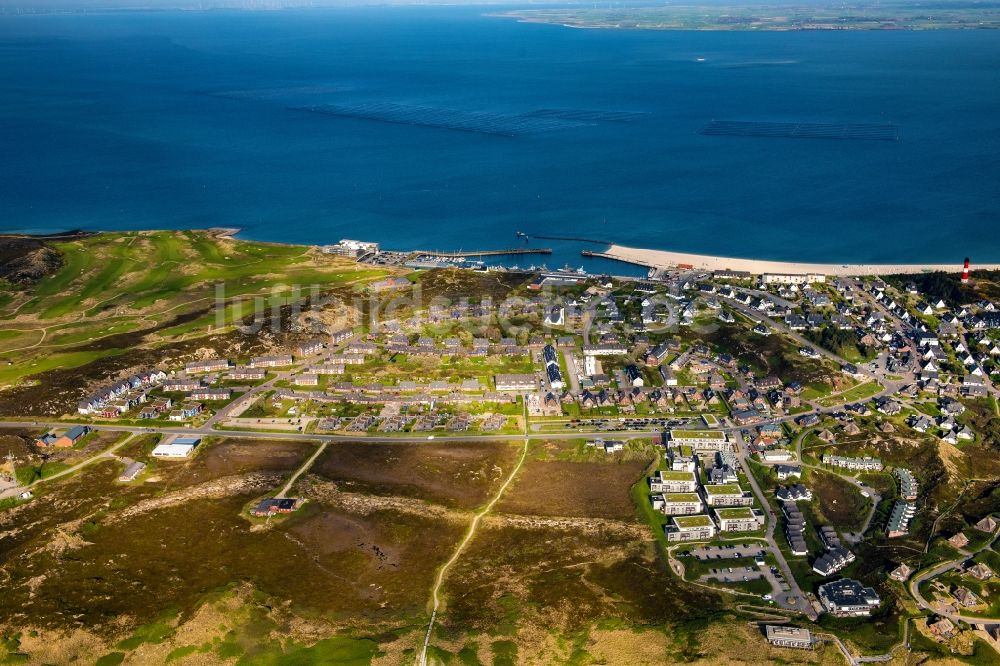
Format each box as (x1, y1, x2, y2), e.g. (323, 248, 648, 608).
(0, 439, 464, 663)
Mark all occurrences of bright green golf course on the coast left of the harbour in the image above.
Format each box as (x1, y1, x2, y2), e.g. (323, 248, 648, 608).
(0, 231, 389, 385)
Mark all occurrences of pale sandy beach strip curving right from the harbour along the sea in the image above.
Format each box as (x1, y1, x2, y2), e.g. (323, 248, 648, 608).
(601, 245, 1000, 276)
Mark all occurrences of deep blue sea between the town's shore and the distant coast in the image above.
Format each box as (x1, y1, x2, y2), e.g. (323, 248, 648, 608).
(0, 7, 1000, 266)
